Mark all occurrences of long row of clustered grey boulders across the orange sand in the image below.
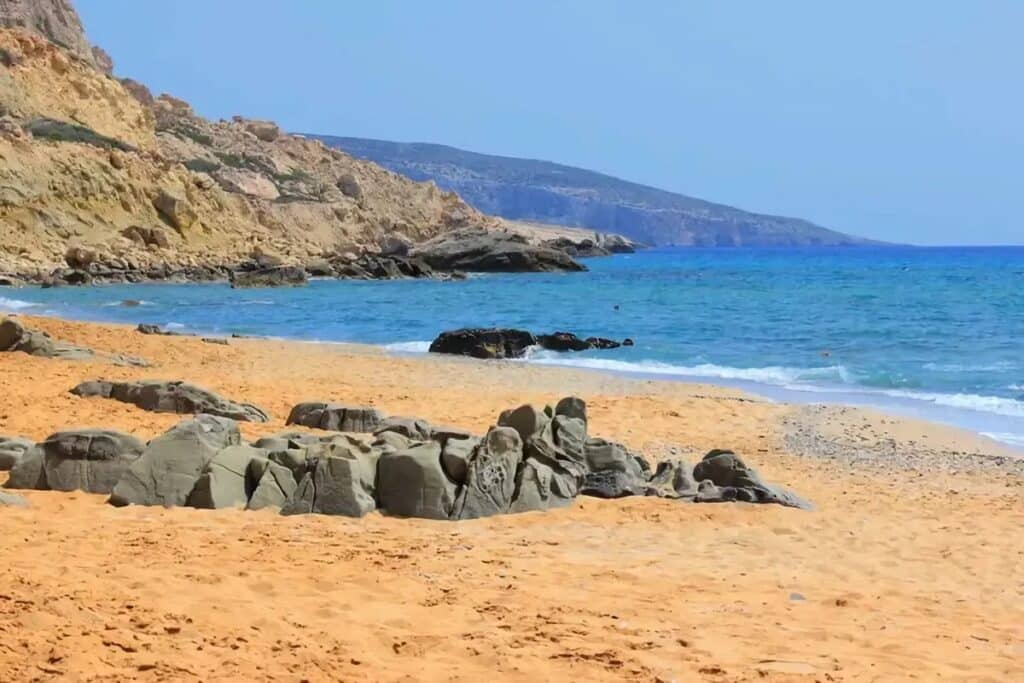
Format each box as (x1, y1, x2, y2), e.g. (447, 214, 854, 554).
(0, 395, 809, 511)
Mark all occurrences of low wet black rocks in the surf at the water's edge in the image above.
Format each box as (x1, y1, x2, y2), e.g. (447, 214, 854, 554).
(430, 328, 633, 358)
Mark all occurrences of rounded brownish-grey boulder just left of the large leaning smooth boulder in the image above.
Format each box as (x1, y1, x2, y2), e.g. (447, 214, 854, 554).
(38, 429, 145, 494)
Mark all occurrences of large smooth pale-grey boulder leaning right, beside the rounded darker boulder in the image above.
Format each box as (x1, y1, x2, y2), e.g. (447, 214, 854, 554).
(110, 415, 242, 507)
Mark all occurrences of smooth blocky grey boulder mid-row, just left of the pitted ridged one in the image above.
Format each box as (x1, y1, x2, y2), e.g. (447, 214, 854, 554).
(377, 441, 457, 519)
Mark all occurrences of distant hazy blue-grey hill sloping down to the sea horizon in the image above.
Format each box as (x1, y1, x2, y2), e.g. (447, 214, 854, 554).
(308, 135, 879, 247)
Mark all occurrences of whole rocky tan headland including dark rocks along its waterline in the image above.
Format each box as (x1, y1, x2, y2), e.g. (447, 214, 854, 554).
(0, 0, 631, 285)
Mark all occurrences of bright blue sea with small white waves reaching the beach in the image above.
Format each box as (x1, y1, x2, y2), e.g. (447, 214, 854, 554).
(0, 247, 1024, 450)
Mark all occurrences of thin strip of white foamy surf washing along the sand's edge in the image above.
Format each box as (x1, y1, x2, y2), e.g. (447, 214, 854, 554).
(6, 296, 1024, 459)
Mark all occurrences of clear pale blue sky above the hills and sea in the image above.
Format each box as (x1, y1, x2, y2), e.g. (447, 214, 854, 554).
(77, 0, 1024, 244)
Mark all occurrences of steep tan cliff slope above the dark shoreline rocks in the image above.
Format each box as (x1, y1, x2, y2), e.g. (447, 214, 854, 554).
(0, 0, 501, 273)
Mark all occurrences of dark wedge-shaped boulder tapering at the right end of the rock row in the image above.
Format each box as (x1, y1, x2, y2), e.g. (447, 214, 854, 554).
(693, 450, 812, 509)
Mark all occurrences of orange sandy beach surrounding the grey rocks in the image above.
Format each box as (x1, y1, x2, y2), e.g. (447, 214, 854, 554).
(0, 316, 1024, 681)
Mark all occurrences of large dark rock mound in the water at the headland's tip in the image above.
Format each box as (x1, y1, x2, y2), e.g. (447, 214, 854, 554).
(411, 228, 587, 272)
